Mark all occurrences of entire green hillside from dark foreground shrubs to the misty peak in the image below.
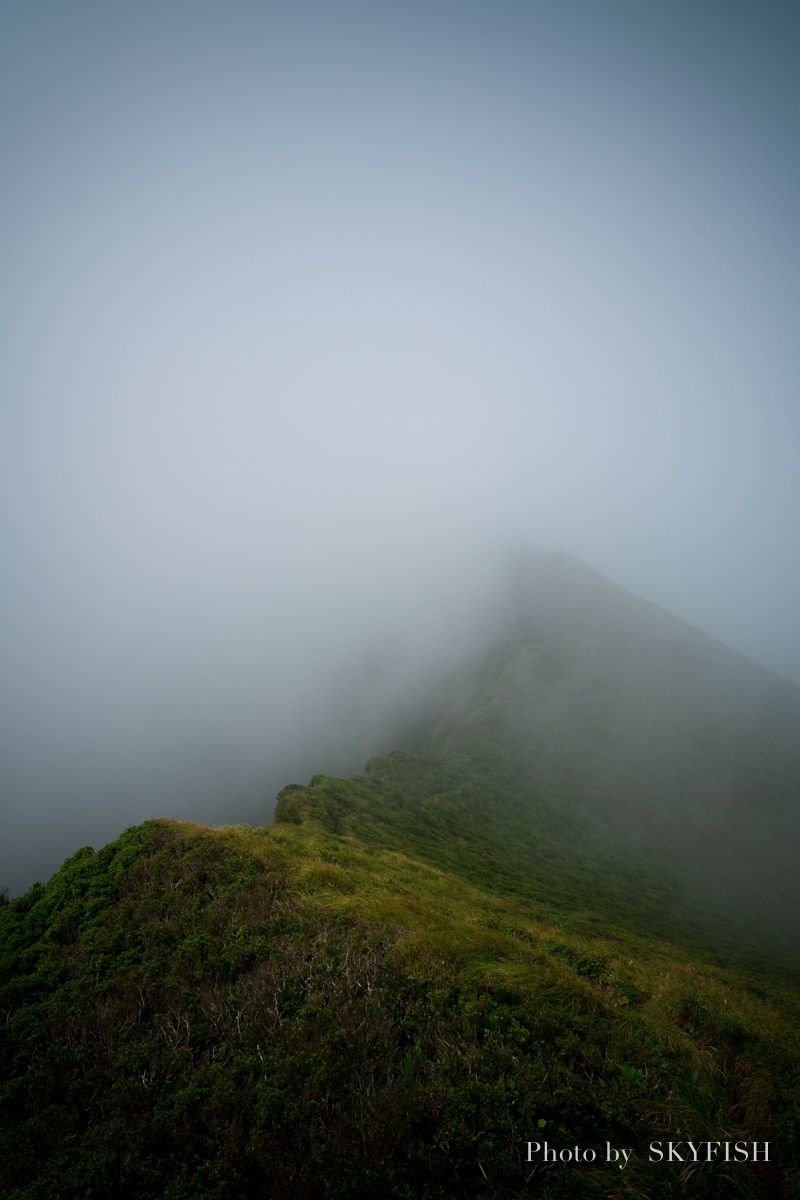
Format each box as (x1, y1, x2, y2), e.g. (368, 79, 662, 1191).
(0, 558, 800, 1200)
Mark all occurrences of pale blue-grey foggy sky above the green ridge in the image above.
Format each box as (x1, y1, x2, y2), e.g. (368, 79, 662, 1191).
(0, 0, 800, 894)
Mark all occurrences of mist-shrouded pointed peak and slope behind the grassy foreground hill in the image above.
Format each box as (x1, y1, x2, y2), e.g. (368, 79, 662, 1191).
(276, 556, 800, 953)
